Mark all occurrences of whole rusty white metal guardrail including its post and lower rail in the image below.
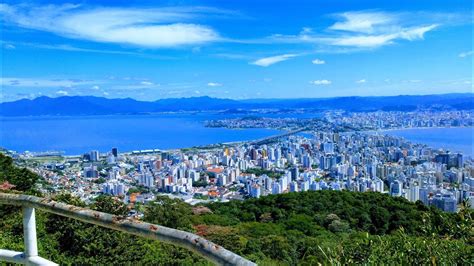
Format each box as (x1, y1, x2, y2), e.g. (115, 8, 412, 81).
(0, 193, 256, 265)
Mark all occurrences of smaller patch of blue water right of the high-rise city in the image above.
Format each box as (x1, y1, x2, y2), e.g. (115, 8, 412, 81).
(383, 127, 474, 158)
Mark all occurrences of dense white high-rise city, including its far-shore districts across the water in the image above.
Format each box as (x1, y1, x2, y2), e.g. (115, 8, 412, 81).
(6, 111, 474, 215)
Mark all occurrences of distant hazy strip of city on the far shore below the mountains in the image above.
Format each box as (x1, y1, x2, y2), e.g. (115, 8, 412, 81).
(205, 110, 474, 132)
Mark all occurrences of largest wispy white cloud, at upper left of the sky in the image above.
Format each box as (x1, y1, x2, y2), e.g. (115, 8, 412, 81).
(0, 4, 220, 48)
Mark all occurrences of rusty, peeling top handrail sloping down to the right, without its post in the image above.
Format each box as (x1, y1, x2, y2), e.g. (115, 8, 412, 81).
(0, 193, 256, 265)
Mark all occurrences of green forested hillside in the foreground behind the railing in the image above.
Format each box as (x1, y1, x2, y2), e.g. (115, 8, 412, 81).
(0, 154, 474, 265)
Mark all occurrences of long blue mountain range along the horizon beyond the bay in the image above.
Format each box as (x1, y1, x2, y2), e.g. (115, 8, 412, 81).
(0, 93, 474, 116)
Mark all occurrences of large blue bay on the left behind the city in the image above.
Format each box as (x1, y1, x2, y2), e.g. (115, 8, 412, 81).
(0, 113, 315, 155)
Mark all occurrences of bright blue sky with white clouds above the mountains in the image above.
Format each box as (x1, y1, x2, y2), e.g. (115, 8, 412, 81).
(0, 0, 473, 101)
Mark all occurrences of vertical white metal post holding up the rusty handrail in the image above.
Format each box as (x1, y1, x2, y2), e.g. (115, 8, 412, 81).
(23, 207, 38, 265)
